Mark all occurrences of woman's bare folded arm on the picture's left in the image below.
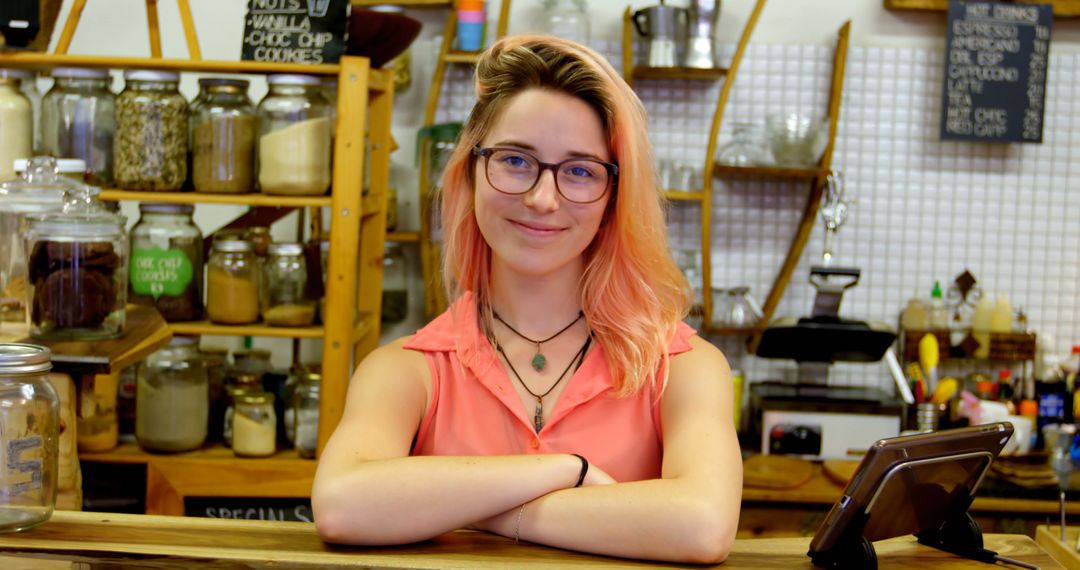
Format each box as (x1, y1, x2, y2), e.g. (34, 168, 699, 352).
(311, 340, 600, 544)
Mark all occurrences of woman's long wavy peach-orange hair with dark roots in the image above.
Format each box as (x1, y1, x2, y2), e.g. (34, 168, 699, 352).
(441, 36, 690, 396)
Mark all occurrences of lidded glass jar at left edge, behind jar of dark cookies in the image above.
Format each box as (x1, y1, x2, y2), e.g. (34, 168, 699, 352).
(0, 157, 78, 338)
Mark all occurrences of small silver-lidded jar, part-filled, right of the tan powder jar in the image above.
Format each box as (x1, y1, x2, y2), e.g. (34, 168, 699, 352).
(262, 243, 315, 326)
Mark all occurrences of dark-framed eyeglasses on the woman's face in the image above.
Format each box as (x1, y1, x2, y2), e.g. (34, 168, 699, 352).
(473, 146, 619, 204)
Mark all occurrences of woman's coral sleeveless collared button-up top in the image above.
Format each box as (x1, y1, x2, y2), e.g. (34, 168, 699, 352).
(405, 293, 694, 481)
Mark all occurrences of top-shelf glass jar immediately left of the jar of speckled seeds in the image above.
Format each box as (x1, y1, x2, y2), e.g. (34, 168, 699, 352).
(40, 67, 117, 186)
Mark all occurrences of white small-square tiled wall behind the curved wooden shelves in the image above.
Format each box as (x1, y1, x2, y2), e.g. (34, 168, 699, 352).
(427, 41, 1080, 390)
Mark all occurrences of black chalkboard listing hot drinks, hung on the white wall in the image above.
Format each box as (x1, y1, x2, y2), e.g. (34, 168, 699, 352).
(941, 0, 1054, 143)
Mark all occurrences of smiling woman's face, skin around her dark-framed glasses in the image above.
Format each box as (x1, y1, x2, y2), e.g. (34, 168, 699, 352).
(473, 89, 612, 276)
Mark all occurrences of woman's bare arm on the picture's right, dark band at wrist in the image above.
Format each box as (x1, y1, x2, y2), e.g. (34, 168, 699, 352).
(473, 337, 742, 562)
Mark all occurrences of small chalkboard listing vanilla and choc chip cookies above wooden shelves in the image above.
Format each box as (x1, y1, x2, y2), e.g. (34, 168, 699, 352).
(241, 0, 349, 64)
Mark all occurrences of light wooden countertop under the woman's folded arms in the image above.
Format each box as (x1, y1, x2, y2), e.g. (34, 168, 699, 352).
(0, 511, 1062, 570)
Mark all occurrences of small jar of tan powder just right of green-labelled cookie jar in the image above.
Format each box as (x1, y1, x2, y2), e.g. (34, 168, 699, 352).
(206, 240, 259, 325)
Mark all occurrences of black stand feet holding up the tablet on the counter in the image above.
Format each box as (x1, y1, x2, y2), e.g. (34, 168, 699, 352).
(808, 494, 998, 569)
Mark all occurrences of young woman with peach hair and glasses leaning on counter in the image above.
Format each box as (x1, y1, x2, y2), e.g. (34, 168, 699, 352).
(312, 37, 742, 562)
